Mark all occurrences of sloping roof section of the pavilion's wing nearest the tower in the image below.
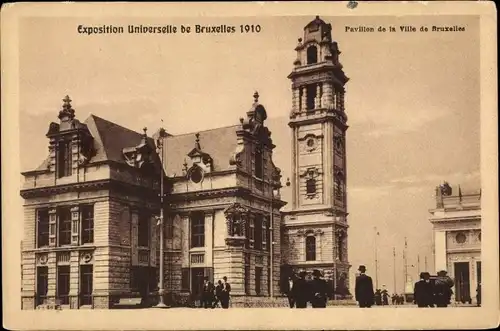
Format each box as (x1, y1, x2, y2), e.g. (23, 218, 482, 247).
(164, 125, 239, 176)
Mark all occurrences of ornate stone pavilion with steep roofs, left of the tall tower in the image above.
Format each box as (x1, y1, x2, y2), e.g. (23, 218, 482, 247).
(21, 93, 285, 309)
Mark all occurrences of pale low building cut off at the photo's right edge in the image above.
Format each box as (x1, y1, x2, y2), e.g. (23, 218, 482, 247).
(429, 182, 481, 302)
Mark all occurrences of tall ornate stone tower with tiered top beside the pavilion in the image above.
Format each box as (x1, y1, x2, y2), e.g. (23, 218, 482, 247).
(282, 16, 350, 293)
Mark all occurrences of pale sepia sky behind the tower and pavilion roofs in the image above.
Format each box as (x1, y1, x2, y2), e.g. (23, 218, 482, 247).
(19, 16, 480, 292)
